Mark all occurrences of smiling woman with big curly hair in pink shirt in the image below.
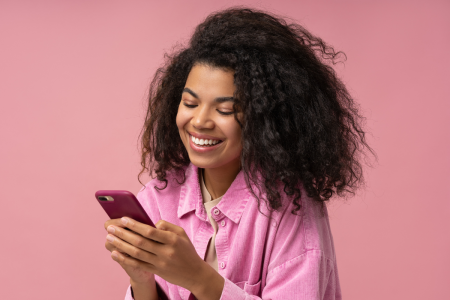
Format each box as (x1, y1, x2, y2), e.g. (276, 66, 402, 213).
(105, 8, 370, 300)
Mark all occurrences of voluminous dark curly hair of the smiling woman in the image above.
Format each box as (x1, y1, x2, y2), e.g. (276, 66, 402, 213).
(139, 7, 373, 214)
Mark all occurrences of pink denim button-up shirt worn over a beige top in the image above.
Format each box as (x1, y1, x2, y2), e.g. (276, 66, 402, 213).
(125, 164, 342, 300)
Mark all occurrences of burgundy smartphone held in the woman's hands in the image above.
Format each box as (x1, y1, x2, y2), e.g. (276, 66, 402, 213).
(95, 190, 155, 227)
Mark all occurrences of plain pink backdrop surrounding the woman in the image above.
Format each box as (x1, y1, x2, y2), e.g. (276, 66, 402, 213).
(0, 0, 450, 300)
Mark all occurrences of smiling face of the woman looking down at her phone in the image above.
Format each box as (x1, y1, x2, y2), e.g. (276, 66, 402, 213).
(177, 64, 242, 169)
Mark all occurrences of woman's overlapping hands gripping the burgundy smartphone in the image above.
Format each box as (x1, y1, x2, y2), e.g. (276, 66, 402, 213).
(107, 218, 209, 292)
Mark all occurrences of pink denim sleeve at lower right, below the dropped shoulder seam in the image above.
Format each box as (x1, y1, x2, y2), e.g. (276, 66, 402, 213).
(220, 250, 341, 300)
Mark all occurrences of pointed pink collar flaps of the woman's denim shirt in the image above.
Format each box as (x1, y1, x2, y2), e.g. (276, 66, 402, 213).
(178, 164, 251, 224)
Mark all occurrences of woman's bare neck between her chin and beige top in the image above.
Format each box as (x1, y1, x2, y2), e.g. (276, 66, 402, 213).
(203, 159, 241, 199)
